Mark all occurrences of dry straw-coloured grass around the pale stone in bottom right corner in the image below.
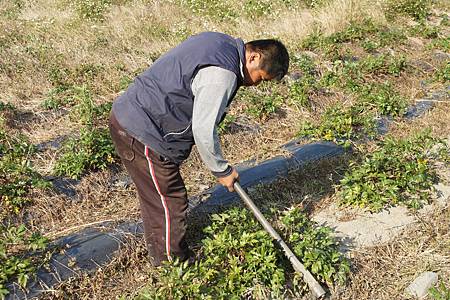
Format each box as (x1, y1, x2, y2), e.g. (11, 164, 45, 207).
(336, 207, 450, 300)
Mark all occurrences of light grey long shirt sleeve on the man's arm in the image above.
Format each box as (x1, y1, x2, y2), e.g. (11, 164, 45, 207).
(191, 66, 237, 177)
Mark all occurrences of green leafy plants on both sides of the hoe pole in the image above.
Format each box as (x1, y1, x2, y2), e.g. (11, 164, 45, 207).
(137, 208, 350, 299)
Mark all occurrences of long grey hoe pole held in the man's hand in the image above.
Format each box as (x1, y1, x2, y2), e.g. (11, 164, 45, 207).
(234, 182, 325, 299)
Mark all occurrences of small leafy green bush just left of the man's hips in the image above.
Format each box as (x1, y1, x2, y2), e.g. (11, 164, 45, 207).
(54, 126, 116, 179)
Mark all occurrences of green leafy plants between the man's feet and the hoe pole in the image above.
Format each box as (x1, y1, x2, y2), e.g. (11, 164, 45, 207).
(138, 208, 285, 299)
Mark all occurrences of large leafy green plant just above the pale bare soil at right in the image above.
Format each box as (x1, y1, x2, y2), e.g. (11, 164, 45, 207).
(338, 132, 445, 211)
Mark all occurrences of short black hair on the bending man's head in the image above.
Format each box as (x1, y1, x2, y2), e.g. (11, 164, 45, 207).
(245, 39, 289, 80)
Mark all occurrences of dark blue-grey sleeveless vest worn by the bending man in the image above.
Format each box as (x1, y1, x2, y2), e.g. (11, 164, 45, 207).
(113, 32, 245, 168)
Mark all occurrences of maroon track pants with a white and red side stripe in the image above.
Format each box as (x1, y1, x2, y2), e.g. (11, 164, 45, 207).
(109, 113, 189, 266)
